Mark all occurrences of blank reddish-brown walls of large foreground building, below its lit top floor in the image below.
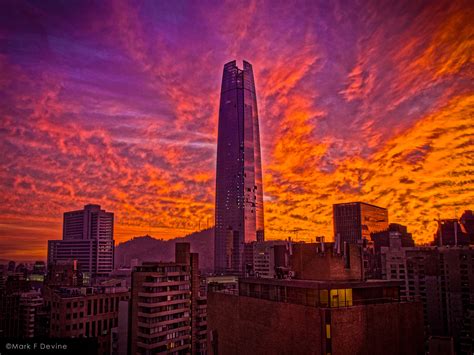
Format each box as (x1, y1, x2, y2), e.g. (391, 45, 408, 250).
(208, 292, 423, 355)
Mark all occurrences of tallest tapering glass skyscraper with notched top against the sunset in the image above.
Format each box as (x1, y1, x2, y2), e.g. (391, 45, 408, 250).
(214, 60, 264, 274)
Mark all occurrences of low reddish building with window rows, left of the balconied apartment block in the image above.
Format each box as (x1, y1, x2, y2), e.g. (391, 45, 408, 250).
(43, 287, 130, 355)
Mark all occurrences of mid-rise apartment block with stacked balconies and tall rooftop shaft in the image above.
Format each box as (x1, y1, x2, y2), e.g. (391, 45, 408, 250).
(129, 243, 207, 354)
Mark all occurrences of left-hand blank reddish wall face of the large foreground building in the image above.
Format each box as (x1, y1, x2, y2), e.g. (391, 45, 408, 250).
(207, 292, 321, 355)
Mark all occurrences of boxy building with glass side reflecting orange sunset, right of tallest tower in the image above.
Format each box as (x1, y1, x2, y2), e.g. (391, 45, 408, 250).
(333, 202, 388, 244)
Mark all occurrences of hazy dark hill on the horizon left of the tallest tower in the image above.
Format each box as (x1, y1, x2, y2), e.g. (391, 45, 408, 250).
(115, 228, 214, 270)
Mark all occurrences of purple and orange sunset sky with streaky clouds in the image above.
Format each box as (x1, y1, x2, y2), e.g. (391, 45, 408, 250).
(0, 0, 474, 259)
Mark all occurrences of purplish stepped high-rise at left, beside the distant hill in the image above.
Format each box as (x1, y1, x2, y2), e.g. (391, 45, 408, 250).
(48, 205, 114, 276)
